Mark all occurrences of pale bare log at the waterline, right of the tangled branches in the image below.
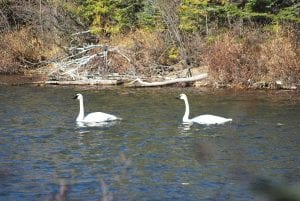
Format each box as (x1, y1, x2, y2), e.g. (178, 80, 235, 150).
(129, 73, 208, 87)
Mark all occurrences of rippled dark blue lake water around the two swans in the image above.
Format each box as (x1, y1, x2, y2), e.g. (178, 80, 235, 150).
(0, 86, 300, 201)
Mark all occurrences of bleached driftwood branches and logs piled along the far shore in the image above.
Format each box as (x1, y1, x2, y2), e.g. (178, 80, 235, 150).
(46, 36, 207, 87)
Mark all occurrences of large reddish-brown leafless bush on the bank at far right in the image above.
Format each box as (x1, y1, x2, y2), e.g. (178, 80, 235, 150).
(204, 27, 300, 87)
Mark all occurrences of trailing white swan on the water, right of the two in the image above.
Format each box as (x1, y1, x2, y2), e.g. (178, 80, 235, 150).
(178, 94, 232, 125)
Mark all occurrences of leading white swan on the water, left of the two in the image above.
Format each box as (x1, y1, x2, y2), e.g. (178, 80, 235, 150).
(73, 94, 119, 123)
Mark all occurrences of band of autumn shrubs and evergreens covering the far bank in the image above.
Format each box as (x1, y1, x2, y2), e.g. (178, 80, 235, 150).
(0, 0, 300, 88)
